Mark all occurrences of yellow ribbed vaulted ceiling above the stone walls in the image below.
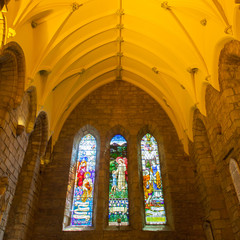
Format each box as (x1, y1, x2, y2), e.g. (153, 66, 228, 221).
(0, 0, 240, 151)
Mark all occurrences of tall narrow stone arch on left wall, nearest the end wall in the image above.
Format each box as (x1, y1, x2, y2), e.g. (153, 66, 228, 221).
(4, 112, 48, 240)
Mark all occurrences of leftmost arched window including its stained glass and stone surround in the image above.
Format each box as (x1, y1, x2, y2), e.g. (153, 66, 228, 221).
(63, 125, 100, 231)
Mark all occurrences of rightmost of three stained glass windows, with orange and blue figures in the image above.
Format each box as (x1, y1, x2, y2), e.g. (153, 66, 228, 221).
(141, 133, 166, 225)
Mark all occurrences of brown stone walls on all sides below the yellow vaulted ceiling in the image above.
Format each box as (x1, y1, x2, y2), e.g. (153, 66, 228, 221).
(0, 41, 240, 240)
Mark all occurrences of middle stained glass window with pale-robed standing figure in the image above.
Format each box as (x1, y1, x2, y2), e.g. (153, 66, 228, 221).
(108, 135, 129, 226)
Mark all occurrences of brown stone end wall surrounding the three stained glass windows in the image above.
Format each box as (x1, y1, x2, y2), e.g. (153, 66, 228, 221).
(32, 81, 205, 240)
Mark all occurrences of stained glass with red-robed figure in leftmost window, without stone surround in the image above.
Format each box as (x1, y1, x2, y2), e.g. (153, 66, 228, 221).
(71, 134, 96, 226)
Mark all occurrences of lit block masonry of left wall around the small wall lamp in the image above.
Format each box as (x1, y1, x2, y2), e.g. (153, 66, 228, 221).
(0, 95, 29, 239)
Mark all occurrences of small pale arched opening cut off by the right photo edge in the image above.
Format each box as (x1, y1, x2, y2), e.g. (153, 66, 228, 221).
(229, 158, 240, 202)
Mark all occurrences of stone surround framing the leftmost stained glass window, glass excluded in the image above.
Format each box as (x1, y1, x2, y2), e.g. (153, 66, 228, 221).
(63, 124, 100, 231)
